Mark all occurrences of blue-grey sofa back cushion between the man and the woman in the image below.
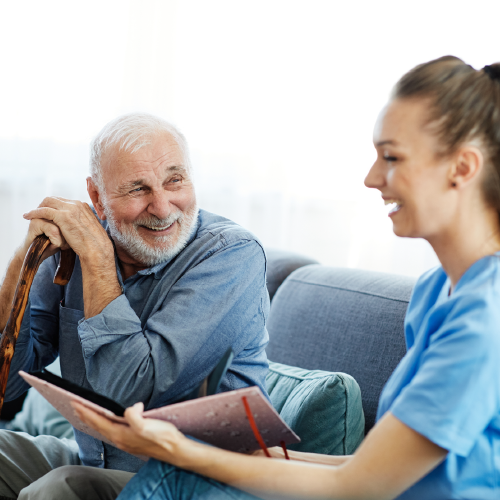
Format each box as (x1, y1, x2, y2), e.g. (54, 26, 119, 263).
(267, 265, 415, 432)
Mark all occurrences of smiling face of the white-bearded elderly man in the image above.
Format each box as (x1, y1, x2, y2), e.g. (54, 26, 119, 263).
(94, 133, 198, 266)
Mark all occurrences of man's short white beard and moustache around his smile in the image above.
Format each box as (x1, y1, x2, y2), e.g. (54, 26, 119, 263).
(104, 204, 198, 267)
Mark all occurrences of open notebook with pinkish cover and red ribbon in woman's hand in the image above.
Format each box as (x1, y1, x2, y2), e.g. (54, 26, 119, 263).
(19, 350, 300, 458)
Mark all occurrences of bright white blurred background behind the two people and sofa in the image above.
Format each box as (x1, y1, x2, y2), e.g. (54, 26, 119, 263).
(0, 0, 500, 276)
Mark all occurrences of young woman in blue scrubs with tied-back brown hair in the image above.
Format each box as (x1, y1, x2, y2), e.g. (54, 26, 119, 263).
(73, 57, 500, 500)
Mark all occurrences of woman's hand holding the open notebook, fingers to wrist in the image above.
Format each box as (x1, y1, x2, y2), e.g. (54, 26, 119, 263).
(72, 402, 190, 465)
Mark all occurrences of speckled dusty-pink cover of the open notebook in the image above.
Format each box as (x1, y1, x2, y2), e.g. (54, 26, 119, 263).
(19, 371, 300, 452)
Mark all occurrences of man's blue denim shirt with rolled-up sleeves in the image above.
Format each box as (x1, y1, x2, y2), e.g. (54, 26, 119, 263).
(6, 210, 269, 472)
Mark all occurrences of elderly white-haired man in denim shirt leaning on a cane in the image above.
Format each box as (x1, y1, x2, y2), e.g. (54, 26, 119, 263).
(0, 114, 269, 499)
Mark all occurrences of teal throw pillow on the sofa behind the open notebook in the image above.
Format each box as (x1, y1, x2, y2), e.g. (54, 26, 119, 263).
(266, 362, 365, 455)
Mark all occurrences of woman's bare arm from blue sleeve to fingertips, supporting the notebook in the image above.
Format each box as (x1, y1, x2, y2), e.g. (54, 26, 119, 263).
(73, 403, 447, 500)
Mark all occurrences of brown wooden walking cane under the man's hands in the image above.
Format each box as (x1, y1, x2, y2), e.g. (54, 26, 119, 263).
(0, 234, 76, 413)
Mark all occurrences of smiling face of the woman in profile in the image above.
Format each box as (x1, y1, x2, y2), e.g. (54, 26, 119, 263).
(365, 99, 453, 240)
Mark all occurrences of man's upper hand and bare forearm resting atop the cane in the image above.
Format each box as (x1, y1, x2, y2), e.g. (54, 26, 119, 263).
(24, 197, 122, 319)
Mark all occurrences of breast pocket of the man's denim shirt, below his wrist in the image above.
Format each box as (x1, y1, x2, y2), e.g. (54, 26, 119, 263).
(59, 305, 85, 385)
